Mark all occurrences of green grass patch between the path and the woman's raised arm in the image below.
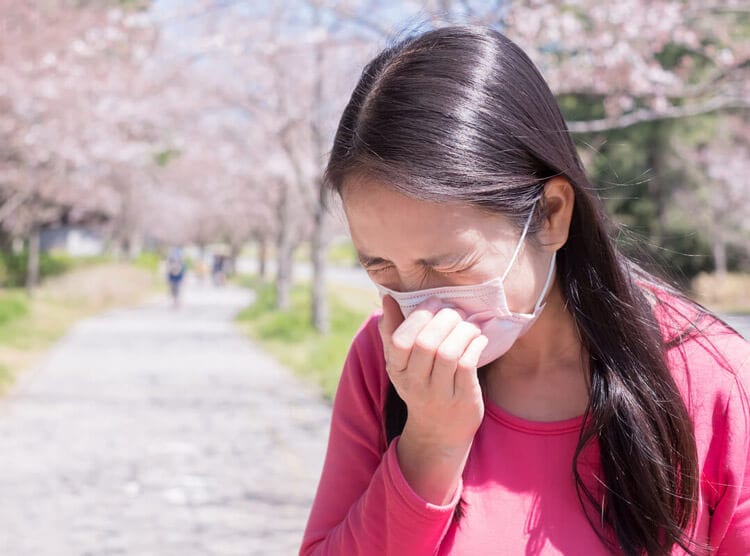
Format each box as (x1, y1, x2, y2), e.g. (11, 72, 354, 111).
(237, 277, 379, 399)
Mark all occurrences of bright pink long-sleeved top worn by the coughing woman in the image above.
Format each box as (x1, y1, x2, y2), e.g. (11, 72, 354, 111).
(300, 302, 750, 556)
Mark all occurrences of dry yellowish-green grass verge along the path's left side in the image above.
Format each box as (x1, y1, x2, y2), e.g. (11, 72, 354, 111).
(0, 263, 155, 392)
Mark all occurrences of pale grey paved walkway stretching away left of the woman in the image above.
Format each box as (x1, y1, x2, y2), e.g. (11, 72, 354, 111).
(0, 286, 330, 556)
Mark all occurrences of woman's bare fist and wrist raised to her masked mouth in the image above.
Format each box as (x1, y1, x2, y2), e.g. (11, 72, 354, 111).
(378, 296, 487, 504)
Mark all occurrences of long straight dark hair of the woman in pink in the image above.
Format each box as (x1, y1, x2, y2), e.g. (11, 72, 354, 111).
(326, 26, 698, 555)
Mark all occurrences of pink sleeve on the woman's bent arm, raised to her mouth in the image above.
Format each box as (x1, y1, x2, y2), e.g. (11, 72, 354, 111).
(300, 317, 461, 556)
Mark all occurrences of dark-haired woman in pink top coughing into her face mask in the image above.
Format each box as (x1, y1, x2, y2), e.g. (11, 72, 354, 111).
(300, 27, 750, 556)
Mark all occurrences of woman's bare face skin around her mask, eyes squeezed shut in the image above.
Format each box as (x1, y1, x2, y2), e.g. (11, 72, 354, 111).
(342, 180, 554, 312)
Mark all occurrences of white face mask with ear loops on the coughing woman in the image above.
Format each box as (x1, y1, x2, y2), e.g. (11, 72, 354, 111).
(375, 204, 555, 367)
